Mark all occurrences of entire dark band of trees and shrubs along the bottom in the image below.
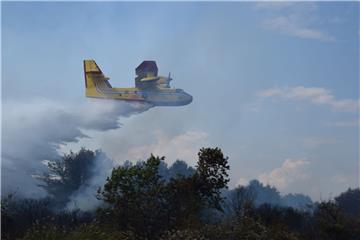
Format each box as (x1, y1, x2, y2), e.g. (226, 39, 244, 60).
(1, 148, 360, 240)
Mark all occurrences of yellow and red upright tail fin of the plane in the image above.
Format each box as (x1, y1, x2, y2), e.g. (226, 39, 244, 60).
(84, 60, 111, 96)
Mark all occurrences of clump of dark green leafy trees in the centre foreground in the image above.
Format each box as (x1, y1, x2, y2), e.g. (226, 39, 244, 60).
(99, 148, 229, 239)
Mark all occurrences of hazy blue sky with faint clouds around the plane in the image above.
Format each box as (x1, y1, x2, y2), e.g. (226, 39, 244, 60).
(2, 2, 360, 200)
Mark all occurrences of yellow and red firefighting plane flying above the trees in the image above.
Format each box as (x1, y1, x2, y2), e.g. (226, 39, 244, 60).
(84, 60, 192, 106)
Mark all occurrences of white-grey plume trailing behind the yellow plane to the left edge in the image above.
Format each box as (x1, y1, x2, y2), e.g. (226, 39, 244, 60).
(1, 99, 152, 198)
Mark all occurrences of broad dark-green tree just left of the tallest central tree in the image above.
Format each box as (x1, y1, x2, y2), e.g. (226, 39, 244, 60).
(98, 155, 166, 239)
